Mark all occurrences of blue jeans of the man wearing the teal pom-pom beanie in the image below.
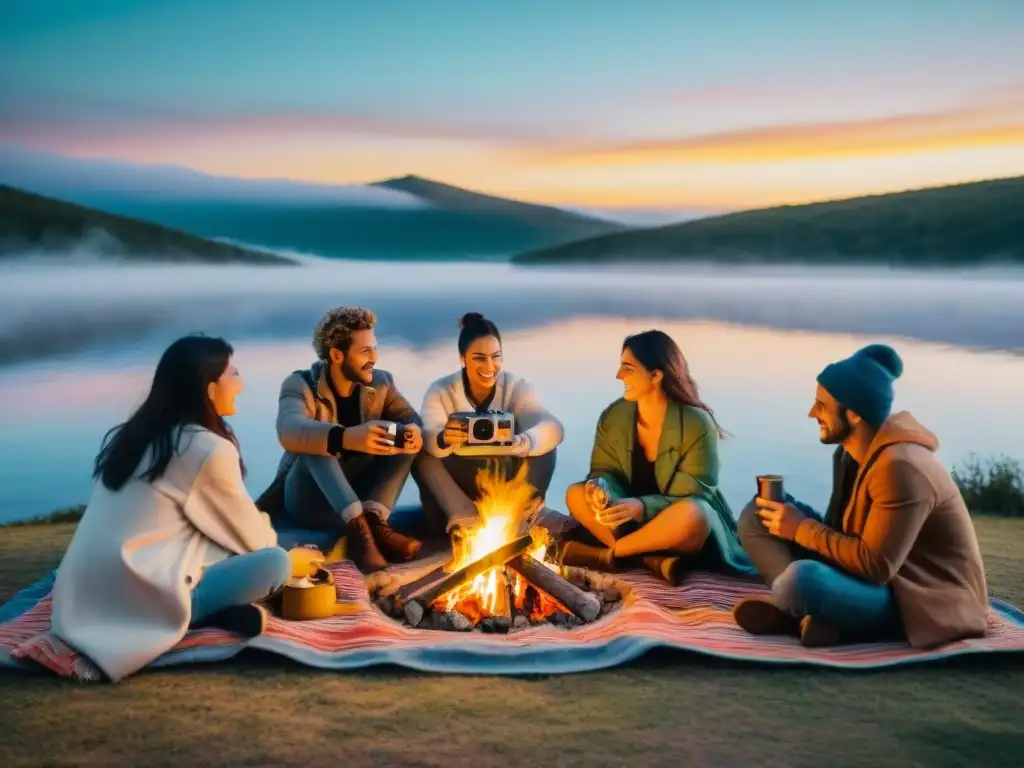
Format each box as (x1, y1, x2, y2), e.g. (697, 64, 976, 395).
(771, 560, 902, 640)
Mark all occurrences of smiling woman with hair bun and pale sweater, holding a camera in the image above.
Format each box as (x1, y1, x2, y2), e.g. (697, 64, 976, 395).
(420, 312, 564, 530)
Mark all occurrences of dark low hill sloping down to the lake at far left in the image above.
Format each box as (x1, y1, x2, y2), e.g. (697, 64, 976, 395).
(0, 185, 295, 264)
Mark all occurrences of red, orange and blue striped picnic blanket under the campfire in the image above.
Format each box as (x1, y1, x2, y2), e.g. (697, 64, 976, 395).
(6, 561, 1024, 680)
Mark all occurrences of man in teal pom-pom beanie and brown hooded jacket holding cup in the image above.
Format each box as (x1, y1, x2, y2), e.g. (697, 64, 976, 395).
(733, 344, 988, 647)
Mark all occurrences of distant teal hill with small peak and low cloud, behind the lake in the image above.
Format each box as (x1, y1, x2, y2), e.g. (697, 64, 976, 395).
(0, 146, 628, 259)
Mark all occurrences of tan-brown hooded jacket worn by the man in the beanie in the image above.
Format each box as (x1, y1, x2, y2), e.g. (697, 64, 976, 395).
(796, 412, 988, 648)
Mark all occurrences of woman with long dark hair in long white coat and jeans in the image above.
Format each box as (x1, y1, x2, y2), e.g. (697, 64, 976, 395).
(52, 336, 292, 682)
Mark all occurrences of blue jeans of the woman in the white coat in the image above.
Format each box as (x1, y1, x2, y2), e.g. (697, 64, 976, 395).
(191, 547, 292, 624)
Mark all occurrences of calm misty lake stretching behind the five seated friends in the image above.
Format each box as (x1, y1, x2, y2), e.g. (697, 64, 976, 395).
(0, 262, 1024, 521)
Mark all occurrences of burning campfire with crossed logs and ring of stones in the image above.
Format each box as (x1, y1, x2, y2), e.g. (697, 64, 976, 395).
(377, 465, 622, 633)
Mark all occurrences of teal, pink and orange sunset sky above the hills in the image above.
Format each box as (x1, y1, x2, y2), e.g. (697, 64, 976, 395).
(0, 0, 1024, 210)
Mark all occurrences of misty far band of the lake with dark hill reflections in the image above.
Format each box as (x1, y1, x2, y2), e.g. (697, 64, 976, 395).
(0, 260, 1024, 365)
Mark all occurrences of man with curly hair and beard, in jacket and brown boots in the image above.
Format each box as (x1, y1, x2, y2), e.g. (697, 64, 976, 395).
(257, 307, 423, 571)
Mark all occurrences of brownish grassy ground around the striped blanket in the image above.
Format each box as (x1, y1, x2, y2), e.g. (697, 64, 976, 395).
(0, 518, 1024, 768)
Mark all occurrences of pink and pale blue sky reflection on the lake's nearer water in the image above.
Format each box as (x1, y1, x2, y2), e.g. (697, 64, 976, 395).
(0, 317, 1024, 520)
